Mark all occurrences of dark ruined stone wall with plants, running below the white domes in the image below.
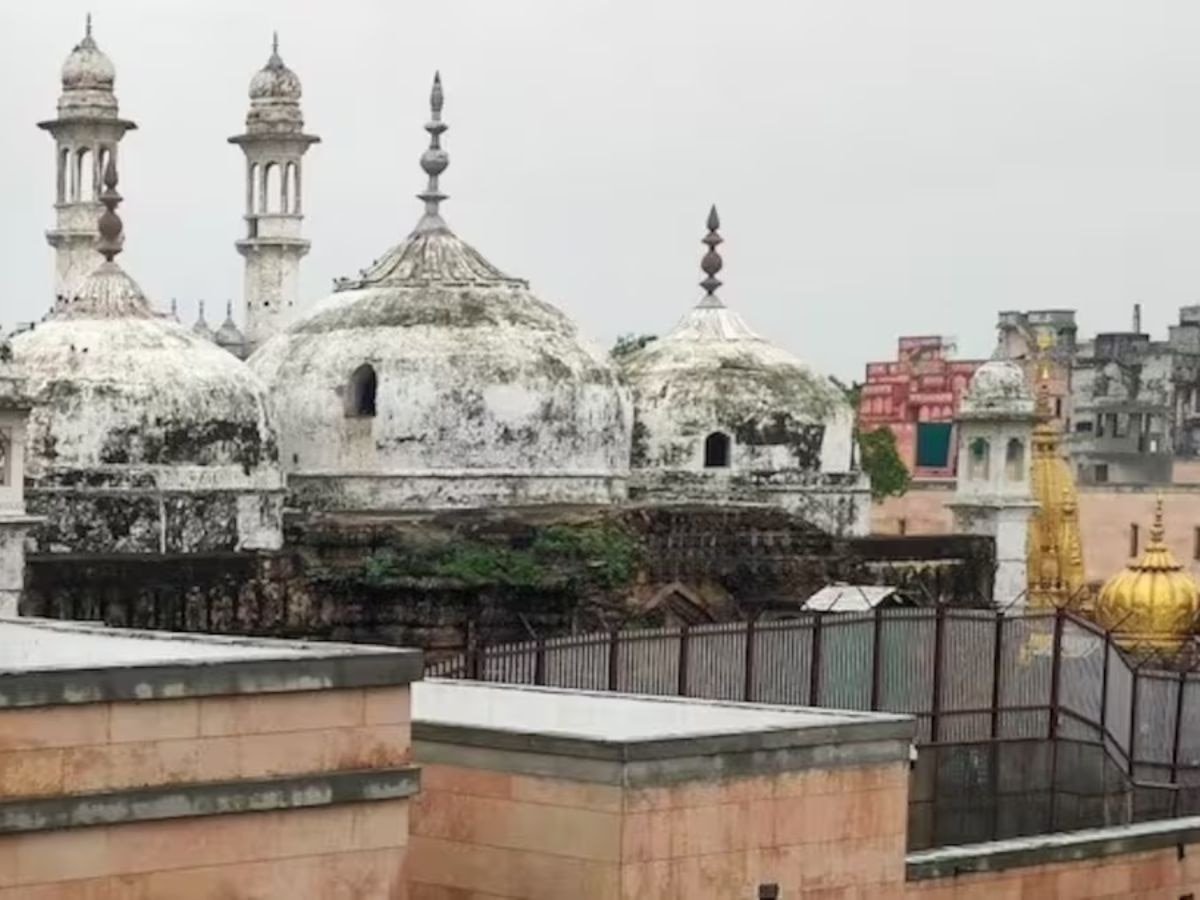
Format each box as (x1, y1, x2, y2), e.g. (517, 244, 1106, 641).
(22, 506, 992, 652)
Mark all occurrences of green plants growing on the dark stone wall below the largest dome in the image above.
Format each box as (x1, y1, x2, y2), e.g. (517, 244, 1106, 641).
(326, 523, 641, 589)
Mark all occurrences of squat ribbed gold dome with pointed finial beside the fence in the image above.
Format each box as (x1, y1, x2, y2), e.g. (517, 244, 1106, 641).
(1094, 498, 1200, 650)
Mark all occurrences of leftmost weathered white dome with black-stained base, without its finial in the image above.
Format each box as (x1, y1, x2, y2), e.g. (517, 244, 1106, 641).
(12, 263, 283, 552)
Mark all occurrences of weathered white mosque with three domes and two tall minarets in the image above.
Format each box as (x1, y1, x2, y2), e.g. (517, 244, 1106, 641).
(5, 18, 870, 619)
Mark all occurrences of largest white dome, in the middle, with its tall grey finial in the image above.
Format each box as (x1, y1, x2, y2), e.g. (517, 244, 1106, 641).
(250, 78, 630, 510)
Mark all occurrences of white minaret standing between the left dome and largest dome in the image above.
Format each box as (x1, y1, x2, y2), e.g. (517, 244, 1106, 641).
(229, 35, 320, 353)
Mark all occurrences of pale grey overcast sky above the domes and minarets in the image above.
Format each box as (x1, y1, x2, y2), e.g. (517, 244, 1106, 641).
(0, 0, 1200, 378)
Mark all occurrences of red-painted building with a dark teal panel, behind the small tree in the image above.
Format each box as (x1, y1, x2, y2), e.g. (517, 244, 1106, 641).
(858, 336, 984, 478)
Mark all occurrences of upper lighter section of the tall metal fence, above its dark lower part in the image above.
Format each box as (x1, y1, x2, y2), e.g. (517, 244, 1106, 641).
(428, 607, 1200, 796)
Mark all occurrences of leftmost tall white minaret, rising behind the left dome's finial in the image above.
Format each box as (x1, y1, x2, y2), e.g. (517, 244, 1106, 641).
(37, 16, 137, 304)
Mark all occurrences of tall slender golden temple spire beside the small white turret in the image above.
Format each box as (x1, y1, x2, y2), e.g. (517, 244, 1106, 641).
(1026, 332, 1088, 610)
